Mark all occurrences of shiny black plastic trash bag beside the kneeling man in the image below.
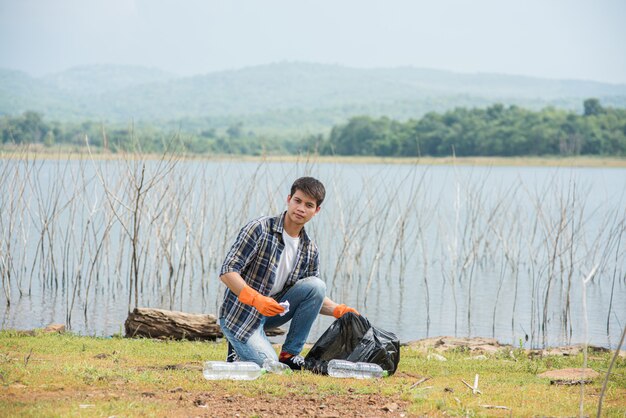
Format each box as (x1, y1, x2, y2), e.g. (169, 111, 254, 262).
(305, 312, 400, 376)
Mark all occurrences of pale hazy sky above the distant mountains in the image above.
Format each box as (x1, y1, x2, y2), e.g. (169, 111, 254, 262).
(0, 0, 626, 84)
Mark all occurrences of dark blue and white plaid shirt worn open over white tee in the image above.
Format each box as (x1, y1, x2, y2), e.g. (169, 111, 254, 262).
(220, 212, 320, 343)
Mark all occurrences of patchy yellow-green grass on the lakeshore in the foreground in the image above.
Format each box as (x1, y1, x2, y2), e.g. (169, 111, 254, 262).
(0, 331, 626, 417)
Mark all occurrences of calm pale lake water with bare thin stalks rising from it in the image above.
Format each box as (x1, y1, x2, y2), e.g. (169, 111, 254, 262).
(0, 159, 626, 347)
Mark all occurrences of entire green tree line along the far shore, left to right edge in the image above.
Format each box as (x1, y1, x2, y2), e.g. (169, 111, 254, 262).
(0, 98, 626, 157)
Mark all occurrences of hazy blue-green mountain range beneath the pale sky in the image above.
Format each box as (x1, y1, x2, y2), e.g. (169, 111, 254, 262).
(0, 63, 626, 129)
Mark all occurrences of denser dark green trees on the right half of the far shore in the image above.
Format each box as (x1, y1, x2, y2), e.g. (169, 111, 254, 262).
(317, 99, 626, 156)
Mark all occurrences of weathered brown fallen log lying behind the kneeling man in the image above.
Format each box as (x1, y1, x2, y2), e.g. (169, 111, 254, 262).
(124, 308, 285, 341)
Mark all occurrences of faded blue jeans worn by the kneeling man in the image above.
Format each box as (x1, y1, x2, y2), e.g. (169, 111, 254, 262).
(220, 277, 326, 365)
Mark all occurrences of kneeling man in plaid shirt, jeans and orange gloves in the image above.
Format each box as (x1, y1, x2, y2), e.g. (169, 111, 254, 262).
(220, 177, 358, 370)
